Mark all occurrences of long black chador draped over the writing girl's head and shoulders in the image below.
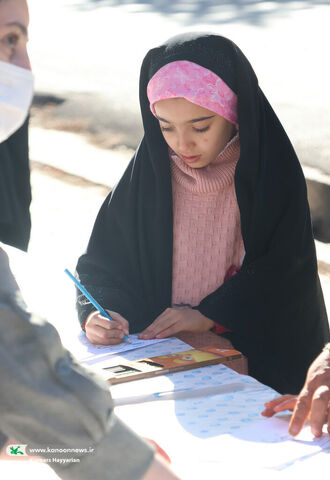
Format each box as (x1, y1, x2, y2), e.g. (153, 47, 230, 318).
(77, 34, 329, 393)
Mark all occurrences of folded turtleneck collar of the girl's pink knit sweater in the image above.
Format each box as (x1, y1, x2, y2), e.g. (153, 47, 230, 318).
(170, 133, 240, 193)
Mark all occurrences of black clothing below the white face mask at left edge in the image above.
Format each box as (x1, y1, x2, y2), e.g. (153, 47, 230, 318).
(0, 120, 31, 251)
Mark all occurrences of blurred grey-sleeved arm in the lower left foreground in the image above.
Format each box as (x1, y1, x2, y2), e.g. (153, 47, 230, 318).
(0, 249, 156, 480)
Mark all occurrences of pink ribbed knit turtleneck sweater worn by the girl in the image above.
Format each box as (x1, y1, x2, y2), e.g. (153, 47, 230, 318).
(171, 134, 244, 306)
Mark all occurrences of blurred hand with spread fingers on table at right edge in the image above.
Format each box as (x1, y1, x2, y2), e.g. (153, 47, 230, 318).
(262, 343, 330, 437)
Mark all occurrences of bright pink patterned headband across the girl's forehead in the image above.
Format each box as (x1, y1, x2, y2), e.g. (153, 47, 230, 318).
(147, 60, 238, 128)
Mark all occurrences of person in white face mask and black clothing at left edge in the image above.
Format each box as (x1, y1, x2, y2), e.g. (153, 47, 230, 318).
(0, 0, 33, 250)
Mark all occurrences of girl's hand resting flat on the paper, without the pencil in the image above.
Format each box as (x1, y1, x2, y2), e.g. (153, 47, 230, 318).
(139, 308, 214, 340)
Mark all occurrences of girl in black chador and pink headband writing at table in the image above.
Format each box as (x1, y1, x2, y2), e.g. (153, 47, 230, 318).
(77, 34, 328, 393)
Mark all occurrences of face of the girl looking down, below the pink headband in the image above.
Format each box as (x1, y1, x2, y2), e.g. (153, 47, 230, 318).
(154, 98, 235, 168)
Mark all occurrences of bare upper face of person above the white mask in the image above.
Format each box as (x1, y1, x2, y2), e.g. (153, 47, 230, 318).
(0, 0, 31, 70)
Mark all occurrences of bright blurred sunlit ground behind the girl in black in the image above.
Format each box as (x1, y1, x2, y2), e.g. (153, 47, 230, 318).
(18, 0, 330, 340)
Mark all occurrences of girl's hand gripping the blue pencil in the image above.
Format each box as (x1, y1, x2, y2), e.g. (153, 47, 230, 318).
(85, 310, 129, 345)
